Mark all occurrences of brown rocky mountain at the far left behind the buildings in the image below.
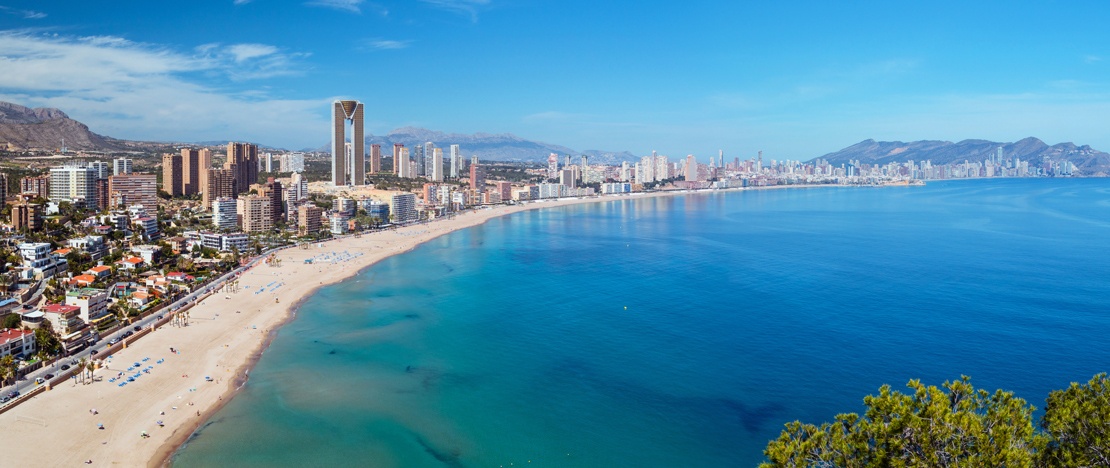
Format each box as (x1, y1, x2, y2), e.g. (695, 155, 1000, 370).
(0, 102, 127, 150)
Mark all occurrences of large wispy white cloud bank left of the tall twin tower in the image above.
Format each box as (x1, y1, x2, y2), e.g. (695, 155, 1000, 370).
(0, 31, 332, 147)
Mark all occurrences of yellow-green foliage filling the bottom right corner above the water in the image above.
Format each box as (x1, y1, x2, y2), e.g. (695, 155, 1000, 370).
(760, 374, 1110, 467)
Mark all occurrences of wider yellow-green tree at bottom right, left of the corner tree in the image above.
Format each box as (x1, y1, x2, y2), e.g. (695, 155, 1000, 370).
(760, 376, 1046, 467)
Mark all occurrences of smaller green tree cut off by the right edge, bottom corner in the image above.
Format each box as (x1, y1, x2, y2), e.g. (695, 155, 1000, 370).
(1041, 373, 1110, 467)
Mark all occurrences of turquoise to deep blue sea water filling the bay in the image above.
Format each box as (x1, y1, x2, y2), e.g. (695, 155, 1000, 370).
(168, 180, 1110, 467)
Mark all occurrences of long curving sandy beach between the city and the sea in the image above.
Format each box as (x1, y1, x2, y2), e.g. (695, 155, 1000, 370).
(0, 189, 710, 466)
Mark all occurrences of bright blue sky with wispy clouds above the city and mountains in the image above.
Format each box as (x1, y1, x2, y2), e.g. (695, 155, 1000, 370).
(0, 0, 1110, 160)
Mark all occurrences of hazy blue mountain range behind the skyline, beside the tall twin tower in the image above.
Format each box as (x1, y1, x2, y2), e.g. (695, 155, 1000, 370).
(305, 126, 638, 164)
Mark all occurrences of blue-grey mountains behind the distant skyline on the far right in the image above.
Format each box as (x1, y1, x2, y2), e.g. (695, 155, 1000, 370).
(817, 136, 1110, 176)
